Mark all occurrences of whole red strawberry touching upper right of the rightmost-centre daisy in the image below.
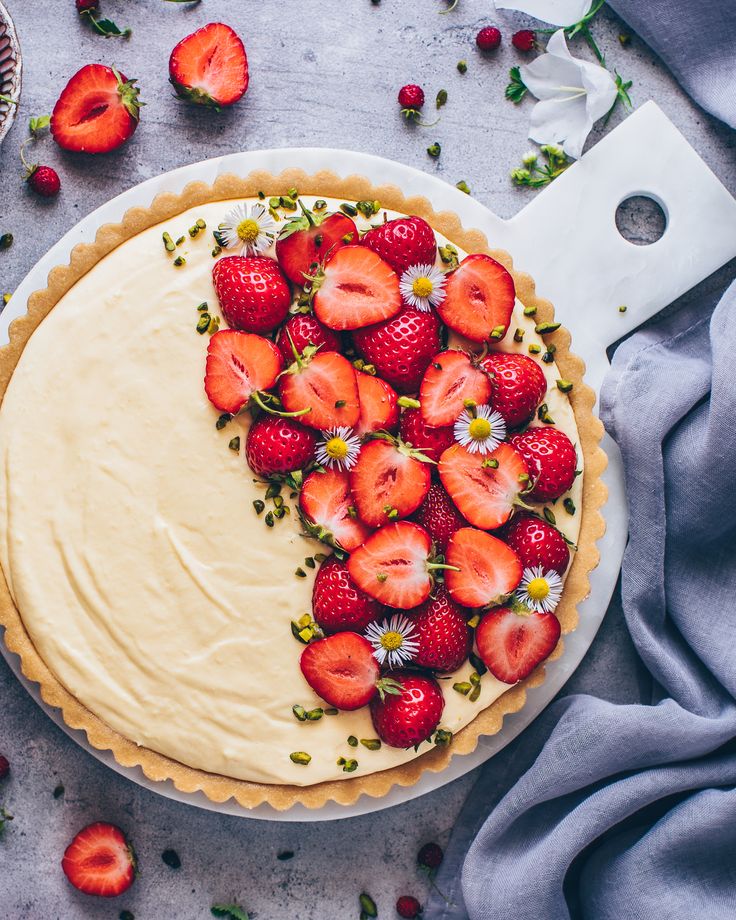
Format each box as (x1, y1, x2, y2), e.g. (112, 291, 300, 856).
(481, 351, 547, 428)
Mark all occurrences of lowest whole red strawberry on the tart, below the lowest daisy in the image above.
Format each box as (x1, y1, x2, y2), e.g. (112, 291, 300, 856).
(371, 671, 445, 748)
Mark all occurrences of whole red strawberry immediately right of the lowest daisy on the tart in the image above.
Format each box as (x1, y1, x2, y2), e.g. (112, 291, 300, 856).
(409, 585, 473, 673)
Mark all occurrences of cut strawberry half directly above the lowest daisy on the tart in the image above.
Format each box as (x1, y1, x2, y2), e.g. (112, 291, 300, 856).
(348, 521, 436, 610)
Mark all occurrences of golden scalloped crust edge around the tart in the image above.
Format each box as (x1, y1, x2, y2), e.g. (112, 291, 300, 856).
(0, 169, 607, 811)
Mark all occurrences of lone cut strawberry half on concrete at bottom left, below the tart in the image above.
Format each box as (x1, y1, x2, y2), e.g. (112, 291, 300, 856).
(61, 821, 136, 898)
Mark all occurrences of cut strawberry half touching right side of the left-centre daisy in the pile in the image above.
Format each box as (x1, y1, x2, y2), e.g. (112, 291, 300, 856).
(350, 439, 432, 527)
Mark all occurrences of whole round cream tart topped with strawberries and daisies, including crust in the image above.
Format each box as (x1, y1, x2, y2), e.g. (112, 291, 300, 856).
(0, 172, 605, 808)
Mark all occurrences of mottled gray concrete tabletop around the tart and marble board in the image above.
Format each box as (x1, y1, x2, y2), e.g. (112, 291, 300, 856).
(0, 0, 736, 920)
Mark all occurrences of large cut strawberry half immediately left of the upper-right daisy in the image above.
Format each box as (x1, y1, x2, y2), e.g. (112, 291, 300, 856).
(313, 245, 402, 329)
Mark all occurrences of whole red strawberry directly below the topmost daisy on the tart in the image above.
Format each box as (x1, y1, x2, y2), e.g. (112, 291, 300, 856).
(212, 256, 291, 332)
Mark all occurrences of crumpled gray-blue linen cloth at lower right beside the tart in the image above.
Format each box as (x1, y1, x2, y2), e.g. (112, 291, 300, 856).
(425, 283, 736, 920)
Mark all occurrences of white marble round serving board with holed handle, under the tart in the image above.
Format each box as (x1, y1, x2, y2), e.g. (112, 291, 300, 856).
(0, 102, 736, 821)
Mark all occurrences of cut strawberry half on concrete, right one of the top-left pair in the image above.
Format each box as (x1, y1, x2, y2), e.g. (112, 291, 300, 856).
(169, 22, 248, 108)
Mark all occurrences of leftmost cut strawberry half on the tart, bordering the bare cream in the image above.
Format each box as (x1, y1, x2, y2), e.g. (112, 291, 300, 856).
(204, 329, 282, 415)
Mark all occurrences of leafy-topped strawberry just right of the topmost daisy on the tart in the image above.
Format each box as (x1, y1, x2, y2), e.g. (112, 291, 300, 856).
(276, 200, 358, 286)
